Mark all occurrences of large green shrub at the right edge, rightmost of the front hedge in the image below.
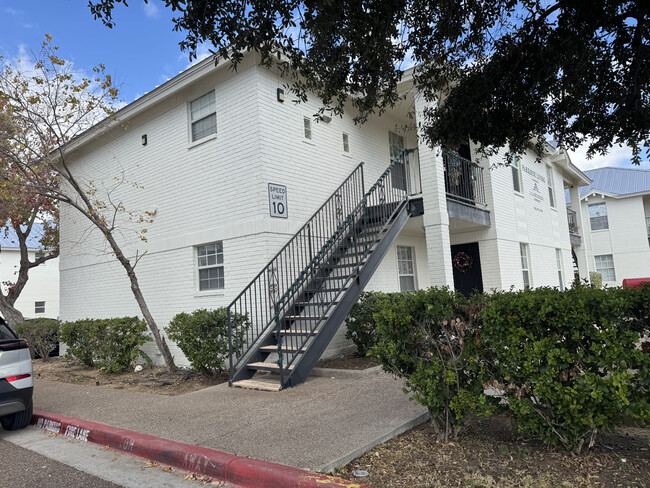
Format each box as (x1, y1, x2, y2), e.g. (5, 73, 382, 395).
(480, 286, 650, 451)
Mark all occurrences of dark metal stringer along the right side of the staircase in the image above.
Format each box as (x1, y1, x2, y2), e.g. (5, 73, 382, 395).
(282, 201, 410, 388)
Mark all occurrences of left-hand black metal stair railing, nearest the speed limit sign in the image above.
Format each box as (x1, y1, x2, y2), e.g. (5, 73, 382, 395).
(227, 163, 364, 381)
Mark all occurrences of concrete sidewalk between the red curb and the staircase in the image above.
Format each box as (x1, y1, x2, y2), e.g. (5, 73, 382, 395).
(34, 368, 427, 472)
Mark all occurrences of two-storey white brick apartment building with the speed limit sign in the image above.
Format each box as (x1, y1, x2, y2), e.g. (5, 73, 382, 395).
(61, 55, 590, 388)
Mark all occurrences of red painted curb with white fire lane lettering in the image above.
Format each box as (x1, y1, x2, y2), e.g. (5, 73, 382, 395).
(32, 411, 370, 488)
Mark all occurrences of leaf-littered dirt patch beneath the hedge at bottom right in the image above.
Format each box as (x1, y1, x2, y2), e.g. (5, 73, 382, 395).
(335, 415, 650, 488)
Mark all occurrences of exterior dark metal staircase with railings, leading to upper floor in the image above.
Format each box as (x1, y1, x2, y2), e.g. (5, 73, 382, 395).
(228, 154, 415, 391)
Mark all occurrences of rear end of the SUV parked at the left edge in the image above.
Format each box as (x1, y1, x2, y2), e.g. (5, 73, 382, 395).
(0, 317, 34, 430)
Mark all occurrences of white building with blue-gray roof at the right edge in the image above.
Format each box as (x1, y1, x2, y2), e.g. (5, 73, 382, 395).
(570, 168, 650, 286)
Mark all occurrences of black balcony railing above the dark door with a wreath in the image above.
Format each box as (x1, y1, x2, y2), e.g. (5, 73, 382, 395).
(442, 149, 487, 206)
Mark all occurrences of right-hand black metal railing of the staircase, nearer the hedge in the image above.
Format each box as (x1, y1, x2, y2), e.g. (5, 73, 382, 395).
(275, 158, 412, 386)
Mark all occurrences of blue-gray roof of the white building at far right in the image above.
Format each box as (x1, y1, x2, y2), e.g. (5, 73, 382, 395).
(580, 168, 650, 198)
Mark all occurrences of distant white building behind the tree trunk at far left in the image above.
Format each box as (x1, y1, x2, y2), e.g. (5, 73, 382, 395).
(0, 223, 59, 319)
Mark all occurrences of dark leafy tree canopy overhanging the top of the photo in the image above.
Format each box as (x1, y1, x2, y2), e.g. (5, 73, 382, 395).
(89, 0, 650, 164)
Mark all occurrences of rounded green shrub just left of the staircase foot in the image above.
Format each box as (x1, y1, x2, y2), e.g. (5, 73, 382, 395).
(165, 308, 250, 376)
